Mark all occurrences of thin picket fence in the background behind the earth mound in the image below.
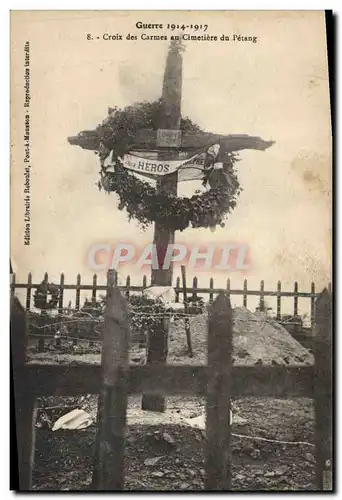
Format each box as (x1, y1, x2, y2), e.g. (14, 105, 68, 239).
(11, 272, 331, 352)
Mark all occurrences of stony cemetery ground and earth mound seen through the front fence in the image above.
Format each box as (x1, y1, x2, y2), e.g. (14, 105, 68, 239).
(29, 308, 315, 491)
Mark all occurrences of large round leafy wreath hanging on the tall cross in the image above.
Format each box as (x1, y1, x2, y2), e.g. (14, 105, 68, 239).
(97, 101, 242, 231)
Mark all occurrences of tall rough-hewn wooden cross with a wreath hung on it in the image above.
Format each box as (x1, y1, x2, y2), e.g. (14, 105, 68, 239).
(68, 42, 273, 412)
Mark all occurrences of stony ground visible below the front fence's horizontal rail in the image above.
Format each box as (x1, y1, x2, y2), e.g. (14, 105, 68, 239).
(33, 396, 315, 491)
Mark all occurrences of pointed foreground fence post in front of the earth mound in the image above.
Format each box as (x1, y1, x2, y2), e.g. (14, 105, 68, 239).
(205, 292, 233, 490)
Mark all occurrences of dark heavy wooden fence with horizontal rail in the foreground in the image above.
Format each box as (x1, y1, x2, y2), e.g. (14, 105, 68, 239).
(11, 273, 332, 491)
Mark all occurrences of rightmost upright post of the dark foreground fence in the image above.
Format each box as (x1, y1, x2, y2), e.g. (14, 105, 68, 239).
(314, 288, 333, 491)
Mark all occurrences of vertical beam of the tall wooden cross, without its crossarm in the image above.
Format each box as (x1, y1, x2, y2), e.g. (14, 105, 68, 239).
(142, 42, 182, 412)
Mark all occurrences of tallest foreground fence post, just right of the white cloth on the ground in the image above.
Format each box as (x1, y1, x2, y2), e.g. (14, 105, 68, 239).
(95, 270, 130, 491)
